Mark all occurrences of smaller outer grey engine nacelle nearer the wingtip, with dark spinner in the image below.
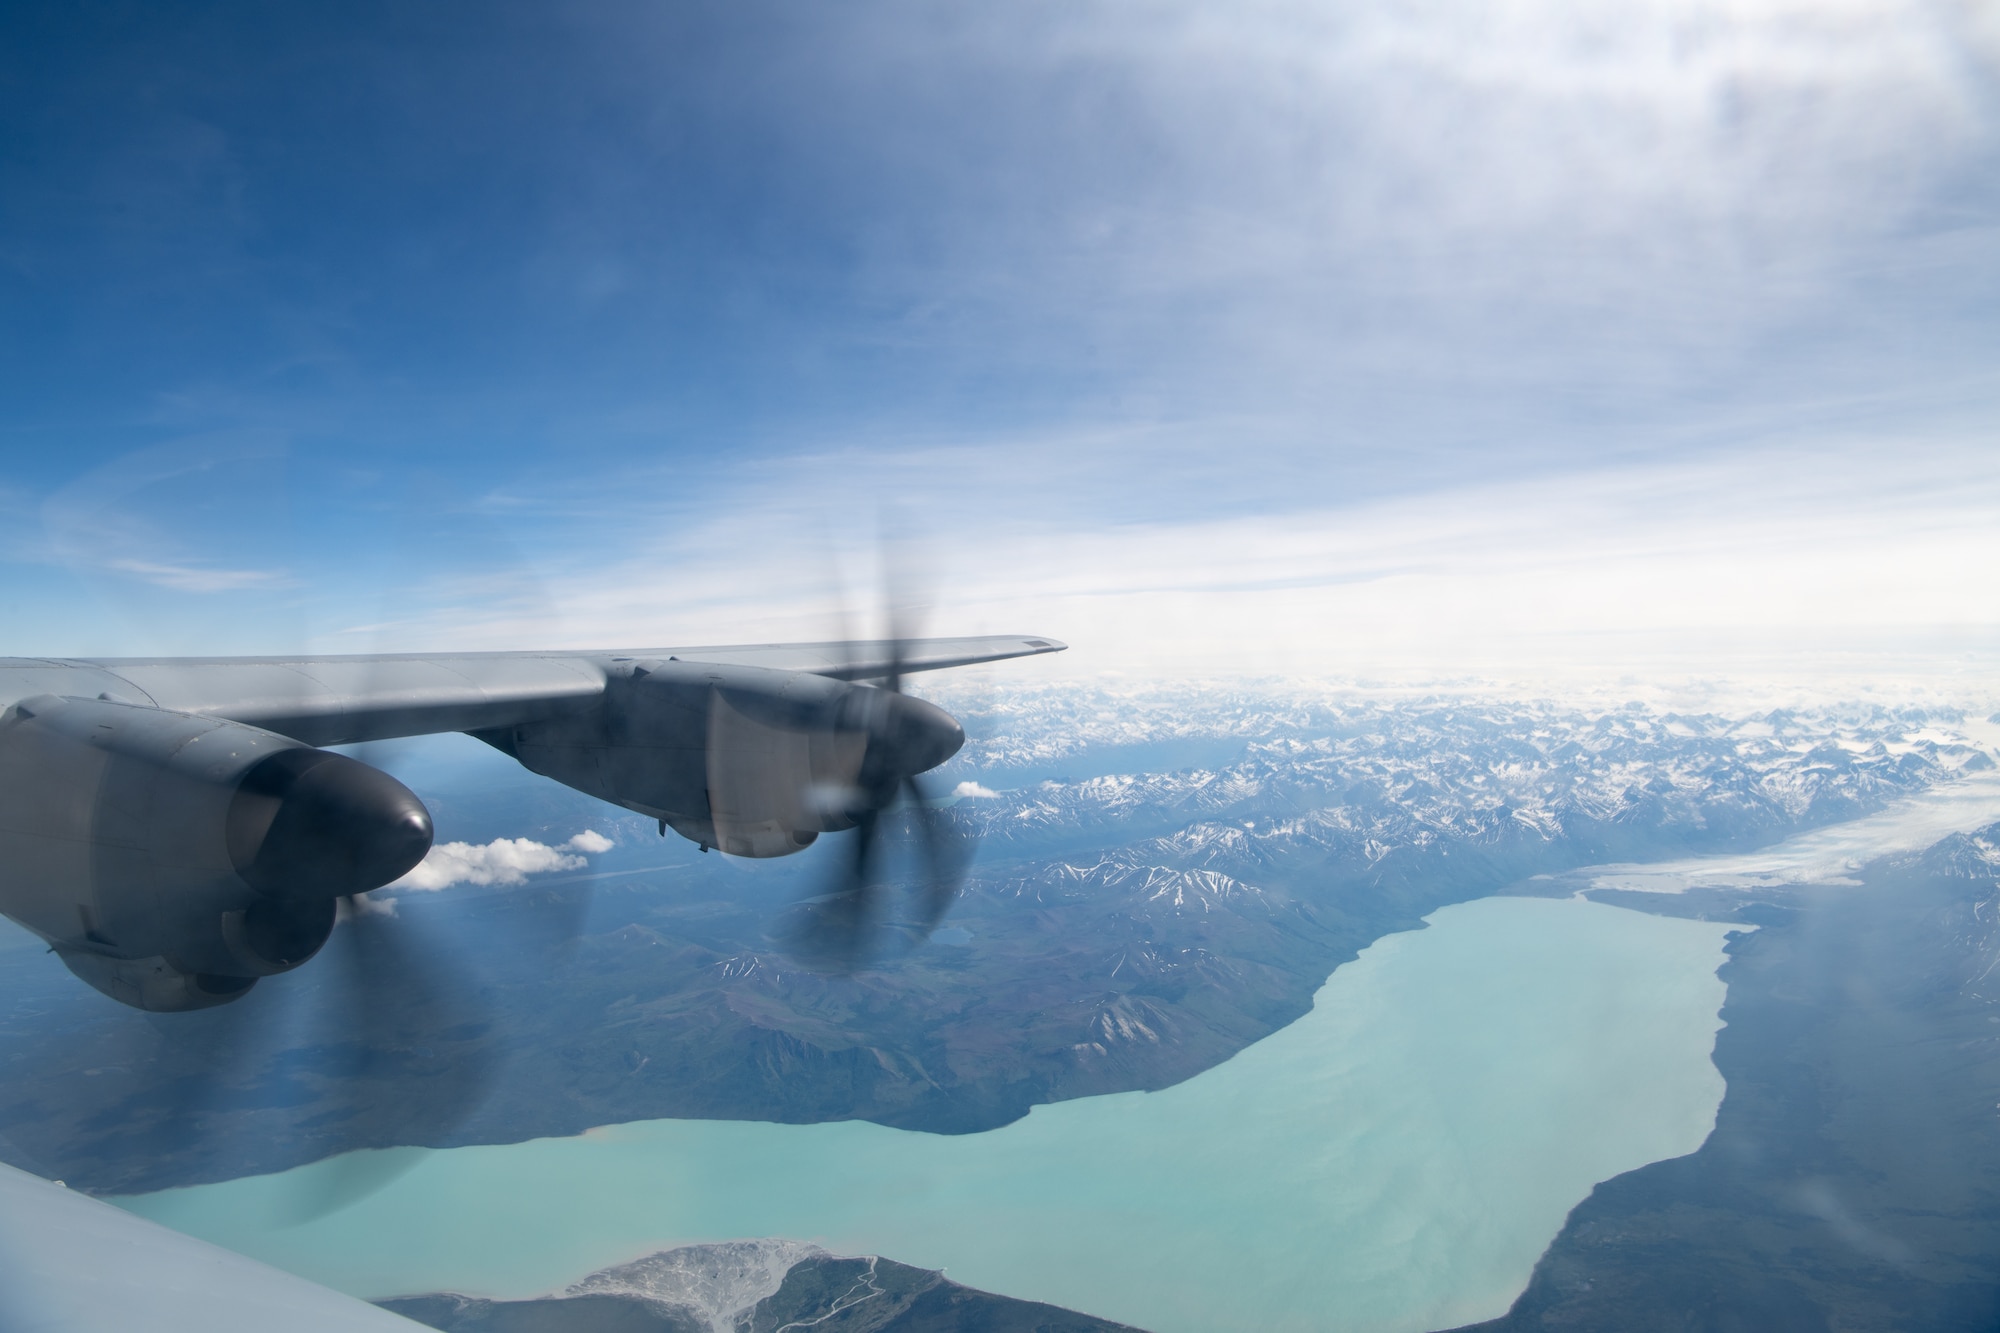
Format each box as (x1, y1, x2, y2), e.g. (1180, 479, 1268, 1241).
(474, 658, 964, 857)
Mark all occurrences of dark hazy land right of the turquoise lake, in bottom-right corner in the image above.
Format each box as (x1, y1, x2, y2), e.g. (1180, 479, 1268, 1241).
(1456, 825, 2000, 1333)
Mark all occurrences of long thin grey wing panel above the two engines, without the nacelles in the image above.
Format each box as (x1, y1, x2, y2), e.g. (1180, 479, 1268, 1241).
(0, 634, 1066, 745)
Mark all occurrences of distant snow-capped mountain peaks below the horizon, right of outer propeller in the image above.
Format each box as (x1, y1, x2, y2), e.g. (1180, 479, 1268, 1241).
(932, 691, 1994, 901)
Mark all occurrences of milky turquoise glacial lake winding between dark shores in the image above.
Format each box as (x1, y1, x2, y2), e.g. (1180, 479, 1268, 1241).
(120, 899, 1730, 1333)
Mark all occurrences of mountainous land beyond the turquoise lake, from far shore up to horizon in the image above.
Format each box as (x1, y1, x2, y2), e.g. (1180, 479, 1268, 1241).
(0, 691, 1990, 1193)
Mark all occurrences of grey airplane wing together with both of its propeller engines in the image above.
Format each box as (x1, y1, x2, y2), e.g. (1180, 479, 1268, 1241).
(0, 634, 1064, 1000)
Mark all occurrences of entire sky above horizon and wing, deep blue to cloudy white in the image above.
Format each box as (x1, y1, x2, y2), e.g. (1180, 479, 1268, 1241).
(0, 0, 2000, 675)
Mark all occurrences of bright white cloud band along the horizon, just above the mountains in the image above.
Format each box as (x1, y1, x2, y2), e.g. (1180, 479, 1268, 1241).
(386, 436, 2000, 681)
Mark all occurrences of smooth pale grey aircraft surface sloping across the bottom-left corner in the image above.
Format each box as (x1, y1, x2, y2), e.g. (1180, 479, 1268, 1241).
(0, 1165, 424, 1333)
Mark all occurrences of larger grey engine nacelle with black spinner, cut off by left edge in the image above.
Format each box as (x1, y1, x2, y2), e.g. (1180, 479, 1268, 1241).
(0, 695, 430, 1011)
